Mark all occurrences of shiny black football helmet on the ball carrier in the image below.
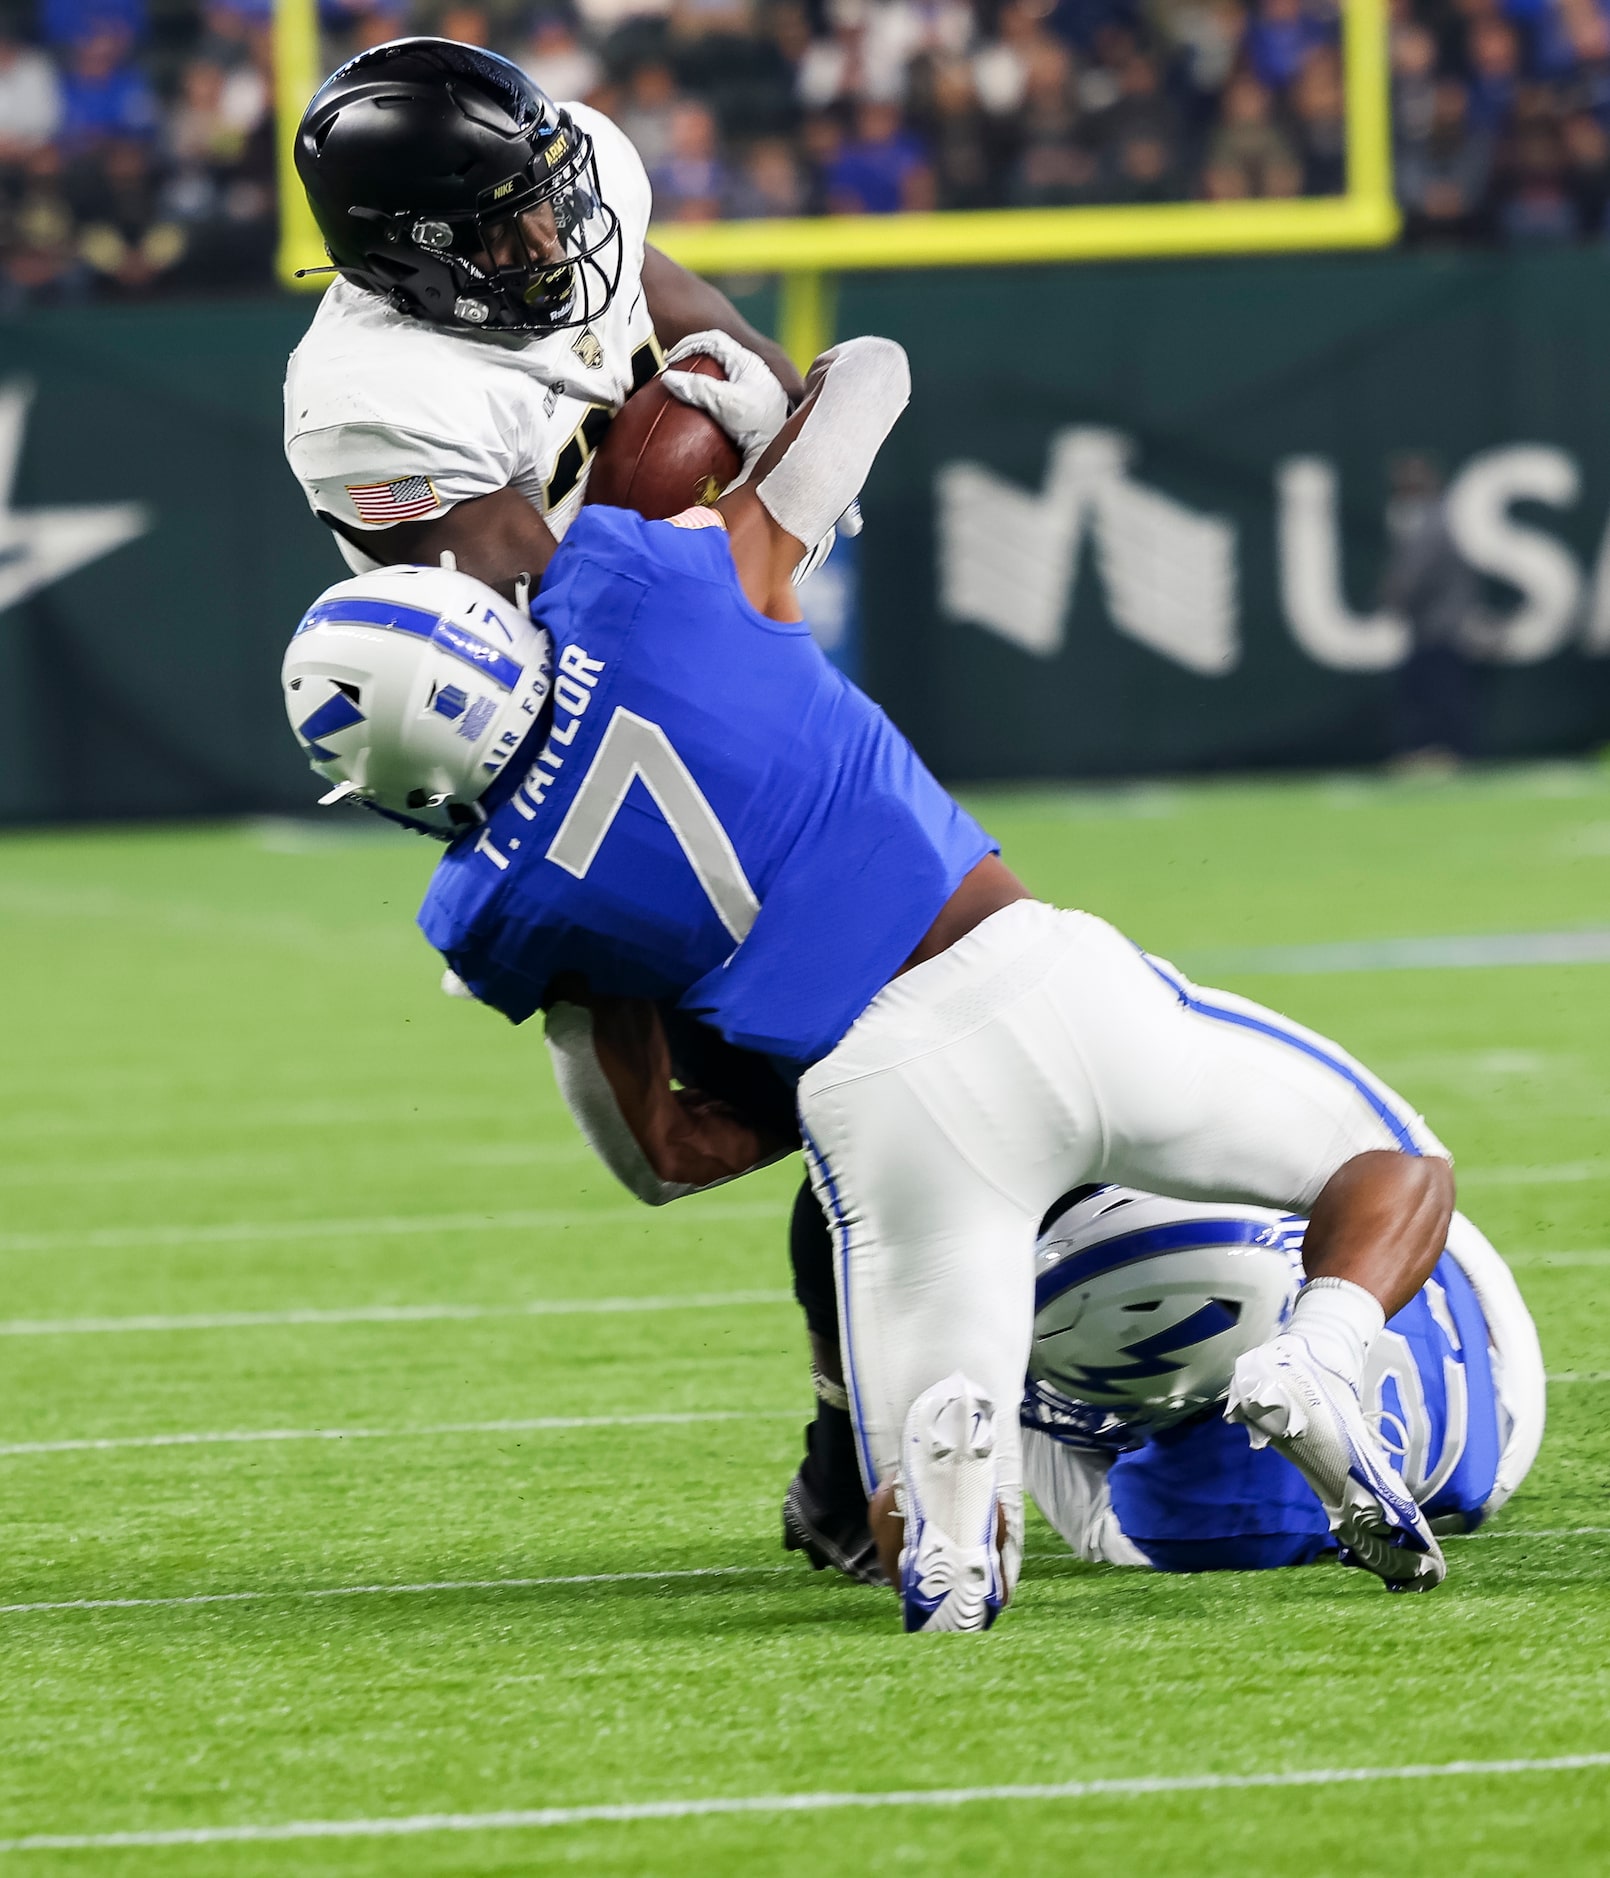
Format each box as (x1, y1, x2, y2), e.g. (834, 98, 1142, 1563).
(297, 39, 622, 332)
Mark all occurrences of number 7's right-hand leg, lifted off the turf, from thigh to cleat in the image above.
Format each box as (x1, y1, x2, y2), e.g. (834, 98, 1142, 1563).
(1029, 920, 1452, 1589)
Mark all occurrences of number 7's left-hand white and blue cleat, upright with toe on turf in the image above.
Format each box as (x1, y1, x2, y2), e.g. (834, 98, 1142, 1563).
(900, 1371, 1007, 1630)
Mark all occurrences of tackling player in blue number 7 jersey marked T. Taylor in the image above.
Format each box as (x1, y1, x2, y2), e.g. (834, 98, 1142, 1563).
(284, 338, 1454, 1630)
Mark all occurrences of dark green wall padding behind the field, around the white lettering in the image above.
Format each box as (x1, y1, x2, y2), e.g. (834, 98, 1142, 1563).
(0, 250, 1610, 823)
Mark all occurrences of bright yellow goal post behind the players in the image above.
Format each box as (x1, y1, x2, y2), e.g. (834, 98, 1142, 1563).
(274, 0, 1400, 364)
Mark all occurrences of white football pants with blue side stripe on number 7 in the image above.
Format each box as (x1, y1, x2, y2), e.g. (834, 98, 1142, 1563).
(798, 900, 1447, 1570)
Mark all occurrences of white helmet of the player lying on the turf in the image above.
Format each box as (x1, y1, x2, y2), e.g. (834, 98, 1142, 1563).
(1024, 1187, 1308, 1448)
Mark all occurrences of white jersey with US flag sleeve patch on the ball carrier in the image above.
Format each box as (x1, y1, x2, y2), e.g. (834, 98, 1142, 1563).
(286, 105, 661, 573)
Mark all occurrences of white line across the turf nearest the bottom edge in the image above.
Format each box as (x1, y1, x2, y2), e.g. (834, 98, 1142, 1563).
(0, 1754, 1610, 1852)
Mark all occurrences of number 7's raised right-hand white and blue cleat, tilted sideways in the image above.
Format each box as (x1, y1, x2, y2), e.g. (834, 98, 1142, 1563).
(1225, 1333, 1448, 1591)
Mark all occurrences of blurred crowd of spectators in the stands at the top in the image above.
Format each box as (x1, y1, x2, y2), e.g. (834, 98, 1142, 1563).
(0, 0, 1610, 308)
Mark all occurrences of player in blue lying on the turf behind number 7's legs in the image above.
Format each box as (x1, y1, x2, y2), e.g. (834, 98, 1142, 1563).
(1022, 1187, 1546, 1572)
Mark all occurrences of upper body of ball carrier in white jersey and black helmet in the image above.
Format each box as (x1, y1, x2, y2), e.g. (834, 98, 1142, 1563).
(286, 39, 802, 595)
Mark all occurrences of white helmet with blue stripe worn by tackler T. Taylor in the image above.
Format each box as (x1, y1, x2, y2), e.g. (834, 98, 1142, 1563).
(280, 567, 552, 839)
